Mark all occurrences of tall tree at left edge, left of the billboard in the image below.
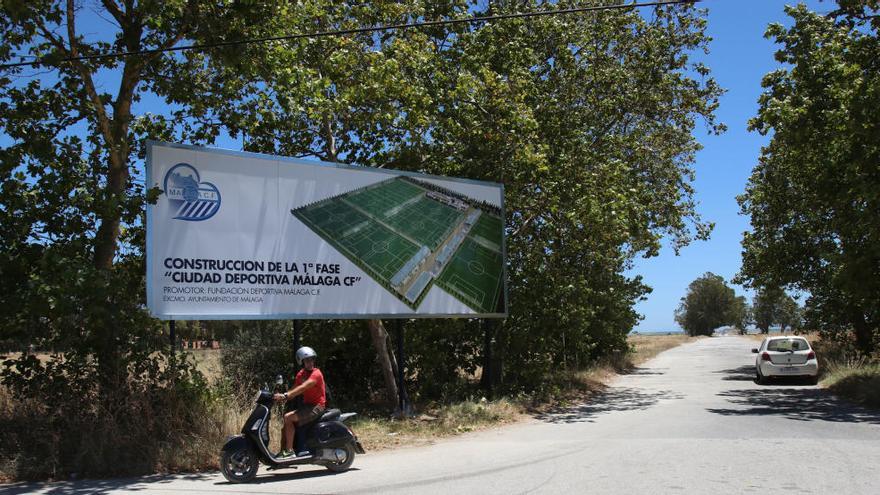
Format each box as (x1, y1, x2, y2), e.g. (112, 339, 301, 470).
(0, 0, 232, 399)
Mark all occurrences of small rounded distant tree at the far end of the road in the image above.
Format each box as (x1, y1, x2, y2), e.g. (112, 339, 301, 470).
(675, 272, 747, 336)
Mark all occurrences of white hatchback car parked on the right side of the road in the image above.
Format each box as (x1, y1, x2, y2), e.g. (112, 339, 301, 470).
(752, 335, 819, 385)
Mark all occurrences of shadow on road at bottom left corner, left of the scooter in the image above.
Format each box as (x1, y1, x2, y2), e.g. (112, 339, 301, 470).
(0, 473, 214, 495)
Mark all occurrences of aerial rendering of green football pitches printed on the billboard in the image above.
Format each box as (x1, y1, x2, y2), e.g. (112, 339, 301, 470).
(291, 176, 505, 314)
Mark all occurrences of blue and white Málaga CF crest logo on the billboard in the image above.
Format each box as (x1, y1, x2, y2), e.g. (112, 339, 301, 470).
(164, 163, 220, 222)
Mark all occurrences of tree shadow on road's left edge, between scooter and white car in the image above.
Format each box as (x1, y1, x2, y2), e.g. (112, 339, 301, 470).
(535, 387, 684, 423)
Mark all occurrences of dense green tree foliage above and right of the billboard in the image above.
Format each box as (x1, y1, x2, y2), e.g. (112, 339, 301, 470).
(196, 1, 723, 389)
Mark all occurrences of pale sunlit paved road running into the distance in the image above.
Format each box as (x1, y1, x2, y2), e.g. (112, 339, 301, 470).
(6, 337, 880, 495)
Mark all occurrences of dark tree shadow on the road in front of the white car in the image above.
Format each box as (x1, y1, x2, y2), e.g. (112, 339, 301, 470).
(706, 387, 880, 424)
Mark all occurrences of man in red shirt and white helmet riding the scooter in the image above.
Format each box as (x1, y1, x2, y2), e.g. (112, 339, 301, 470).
(274, 347, 327, 458)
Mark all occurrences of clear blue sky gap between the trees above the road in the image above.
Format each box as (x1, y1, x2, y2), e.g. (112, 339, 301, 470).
(628, 0, 835, 332)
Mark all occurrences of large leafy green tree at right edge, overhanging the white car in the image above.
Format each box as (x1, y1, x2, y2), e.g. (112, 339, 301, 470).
(737, 0, 880, 354)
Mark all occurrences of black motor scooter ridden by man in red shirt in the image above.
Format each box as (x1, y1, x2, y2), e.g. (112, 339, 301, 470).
(220, 376, 365, 483)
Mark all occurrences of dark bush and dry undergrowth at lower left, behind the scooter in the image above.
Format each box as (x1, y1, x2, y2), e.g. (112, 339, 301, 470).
(0, 354, 221, 479)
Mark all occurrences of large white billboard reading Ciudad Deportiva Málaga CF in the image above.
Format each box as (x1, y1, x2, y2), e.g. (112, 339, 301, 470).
(146, 142, 507, 319)
